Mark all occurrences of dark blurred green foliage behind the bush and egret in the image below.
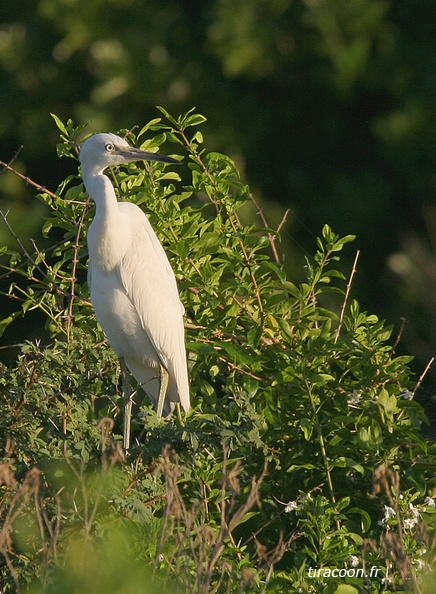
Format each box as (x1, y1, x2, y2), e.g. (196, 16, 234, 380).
(0, 0, 436, 382)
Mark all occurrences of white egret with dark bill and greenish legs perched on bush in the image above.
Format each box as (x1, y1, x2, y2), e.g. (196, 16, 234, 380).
(79, 134, 190, 450)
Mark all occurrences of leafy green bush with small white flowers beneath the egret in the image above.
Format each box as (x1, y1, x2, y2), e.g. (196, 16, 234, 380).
(0, 109, 436, 594)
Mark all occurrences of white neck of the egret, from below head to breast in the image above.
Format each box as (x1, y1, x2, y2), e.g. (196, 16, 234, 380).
(83, 173, 128, 272)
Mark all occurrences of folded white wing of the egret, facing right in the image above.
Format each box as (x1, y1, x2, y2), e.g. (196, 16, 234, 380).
(119, 202, 189, 410)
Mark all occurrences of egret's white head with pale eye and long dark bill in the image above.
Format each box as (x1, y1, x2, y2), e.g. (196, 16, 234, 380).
(79, 133, 179, 172)
